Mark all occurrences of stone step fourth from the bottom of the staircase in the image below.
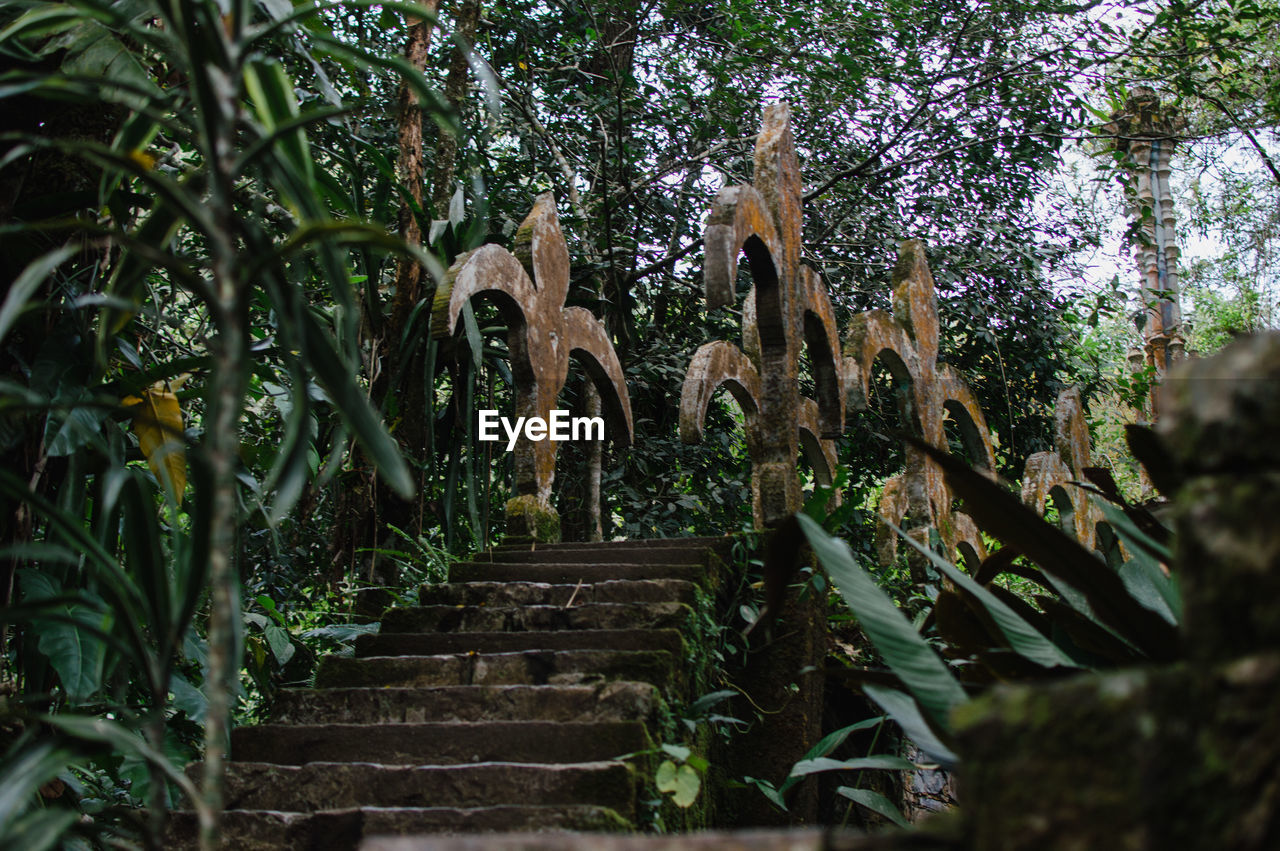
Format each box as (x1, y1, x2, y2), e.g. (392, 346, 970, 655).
(271, 682, 662, 724)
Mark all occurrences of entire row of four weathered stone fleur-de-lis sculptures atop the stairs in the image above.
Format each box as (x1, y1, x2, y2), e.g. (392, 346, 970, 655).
(433, 104, 1094, 550)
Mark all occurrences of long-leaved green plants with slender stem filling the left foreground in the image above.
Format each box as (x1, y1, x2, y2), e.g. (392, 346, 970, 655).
(0, 0, 450, 846)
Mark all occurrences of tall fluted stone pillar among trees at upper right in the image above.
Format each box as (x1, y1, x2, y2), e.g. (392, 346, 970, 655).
(1106, 86, 1185, 422)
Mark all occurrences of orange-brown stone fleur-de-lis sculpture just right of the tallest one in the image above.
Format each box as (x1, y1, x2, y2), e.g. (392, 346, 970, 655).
(844, 239, 996, 563)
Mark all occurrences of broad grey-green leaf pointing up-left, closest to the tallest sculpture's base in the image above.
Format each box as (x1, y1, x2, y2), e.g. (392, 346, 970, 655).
(796, 513, 966, 726)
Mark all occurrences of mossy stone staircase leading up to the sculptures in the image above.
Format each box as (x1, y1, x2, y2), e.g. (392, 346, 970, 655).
(169, 537, 732, 850)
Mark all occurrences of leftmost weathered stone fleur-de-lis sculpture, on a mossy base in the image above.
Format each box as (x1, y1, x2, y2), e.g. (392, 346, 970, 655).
(431, 193, 632, 541)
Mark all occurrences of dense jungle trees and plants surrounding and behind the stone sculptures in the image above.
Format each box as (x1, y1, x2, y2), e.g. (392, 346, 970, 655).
(0, 0, 1280, 848)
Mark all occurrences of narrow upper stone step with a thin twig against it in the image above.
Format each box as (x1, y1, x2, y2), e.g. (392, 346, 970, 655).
(417, 580, 696, 605)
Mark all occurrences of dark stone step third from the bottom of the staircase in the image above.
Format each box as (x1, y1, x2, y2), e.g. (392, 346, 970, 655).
(232, 720, 650, 765)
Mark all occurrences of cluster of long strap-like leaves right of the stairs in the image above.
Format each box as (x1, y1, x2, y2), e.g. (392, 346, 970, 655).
(783, 435, 1181, 820)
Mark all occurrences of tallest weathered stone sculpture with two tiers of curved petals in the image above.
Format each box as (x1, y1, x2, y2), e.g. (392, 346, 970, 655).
(680, 104, 844, 527)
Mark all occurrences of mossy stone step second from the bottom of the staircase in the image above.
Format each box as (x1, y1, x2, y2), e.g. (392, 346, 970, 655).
(211, 761, 635, 819)
